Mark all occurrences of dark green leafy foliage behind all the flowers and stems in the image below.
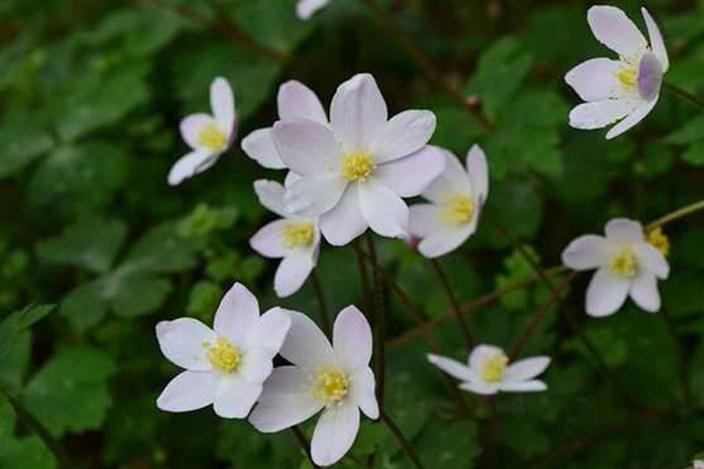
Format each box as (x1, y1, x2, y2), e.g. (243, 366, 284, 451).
(0, 0, 704, 469)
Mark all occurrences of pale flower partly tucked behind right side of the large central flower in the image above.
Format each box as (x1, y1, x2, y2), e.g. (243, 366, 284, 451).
(410, 145, 489, 258)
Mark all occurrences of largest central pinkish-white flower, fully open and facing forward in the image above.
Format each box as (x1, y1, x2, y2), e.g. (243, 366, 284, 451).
(273, 74, 445, 246)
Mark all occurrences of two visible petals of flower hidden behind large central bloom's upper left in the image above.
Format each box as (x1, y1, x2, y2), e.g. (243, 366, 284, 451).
(241, 80, 328, 169)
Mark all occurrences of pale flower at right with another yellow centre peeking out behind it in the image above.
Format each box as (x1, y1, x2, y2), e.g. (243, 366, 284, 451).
(562, 218, 670, 317)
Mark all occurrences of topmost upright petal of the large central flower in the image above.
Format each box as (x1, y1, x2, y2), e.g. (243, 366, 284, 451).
(330, 73, 388, 152)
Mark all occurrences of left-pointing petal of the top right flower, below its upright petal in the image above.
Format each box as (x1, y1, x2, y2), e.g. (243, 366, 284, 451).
(565, 58, 623, 101)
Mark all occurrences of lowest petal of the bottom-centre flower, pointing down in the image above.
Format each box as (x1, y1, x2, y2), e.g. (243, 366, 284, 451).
(311, 401, 359, 466)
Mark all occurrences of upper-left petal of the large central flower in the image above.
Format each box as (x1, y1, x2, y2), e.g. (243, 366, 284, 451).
(273, 119, 341, 175)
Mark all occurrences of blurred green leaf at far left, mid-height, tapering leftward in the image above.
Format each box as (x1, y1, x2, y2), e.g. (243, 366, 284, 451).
(37, 217, 127, 273)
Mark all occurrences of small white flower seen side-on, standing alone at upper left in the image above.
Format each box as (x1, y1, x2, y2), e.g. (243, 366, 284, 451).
(168, 77, 236, 186)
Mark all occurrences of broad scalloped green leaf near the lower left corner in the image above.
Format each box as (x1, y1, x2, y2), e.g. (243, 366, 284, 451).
(22, 347, 115, 437)
